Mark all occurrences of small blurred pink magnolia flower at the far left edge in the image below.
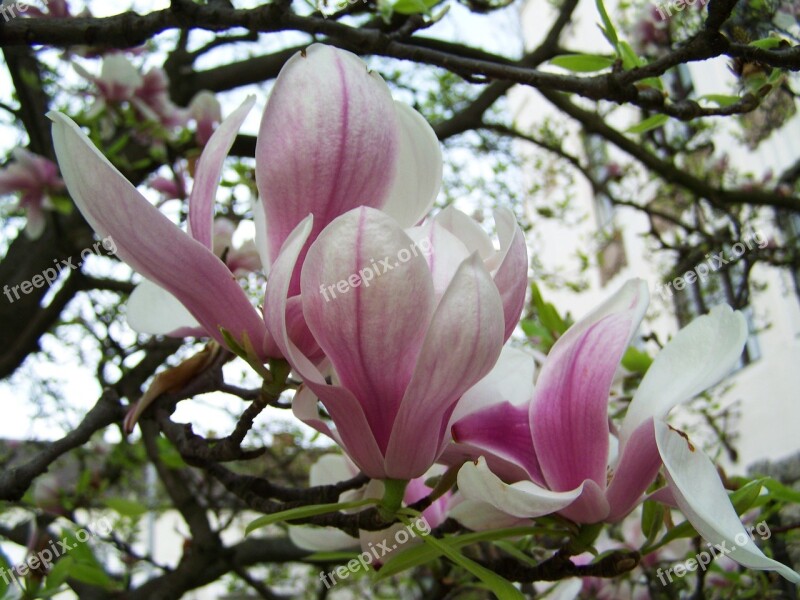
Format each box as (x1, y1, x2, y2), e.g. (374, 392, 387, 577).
(0, 148, 64, 240)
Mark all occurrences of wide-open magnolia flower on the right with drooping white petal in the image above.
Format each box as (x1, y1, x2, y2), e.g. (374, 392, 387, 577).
(453, 281, 800, 581)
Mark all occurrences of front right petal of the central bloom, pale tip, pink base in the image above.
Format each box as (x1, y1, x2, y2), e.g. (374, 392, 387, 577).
(386, 254, 503, 479)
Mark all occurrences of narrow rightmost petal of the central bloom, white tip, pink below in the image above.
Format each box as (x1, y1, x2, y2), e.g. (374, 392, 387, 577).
(489, 208, 528, 340)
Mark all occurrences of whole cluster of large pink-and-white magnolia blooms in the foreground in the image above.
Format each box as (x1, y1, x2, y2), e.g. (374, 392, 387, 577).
(50, 44, 800, 581)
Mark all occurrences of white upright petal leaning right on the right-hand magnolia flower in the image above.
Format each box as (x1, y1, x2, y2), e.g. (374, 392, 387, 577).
(620, 304, 747, 444)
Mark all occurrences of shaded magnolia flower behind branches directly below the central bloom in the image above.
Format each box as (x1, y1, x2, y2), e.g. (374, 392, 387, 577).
(289, 454, 453, 568)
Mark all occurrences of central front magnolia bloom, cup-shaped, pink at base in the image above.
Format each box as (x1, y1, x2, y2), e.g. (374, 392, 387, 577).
(260, 207, 527, 480)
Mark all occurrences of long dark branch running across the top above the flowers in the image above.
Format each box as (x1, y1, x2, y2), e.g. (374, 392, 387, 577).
(0, 0, 800, 120)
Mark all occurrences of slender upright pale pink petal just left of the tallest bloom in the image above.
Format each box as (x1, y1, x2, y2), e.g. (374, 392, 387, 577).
(189, 96, 256, 250)
